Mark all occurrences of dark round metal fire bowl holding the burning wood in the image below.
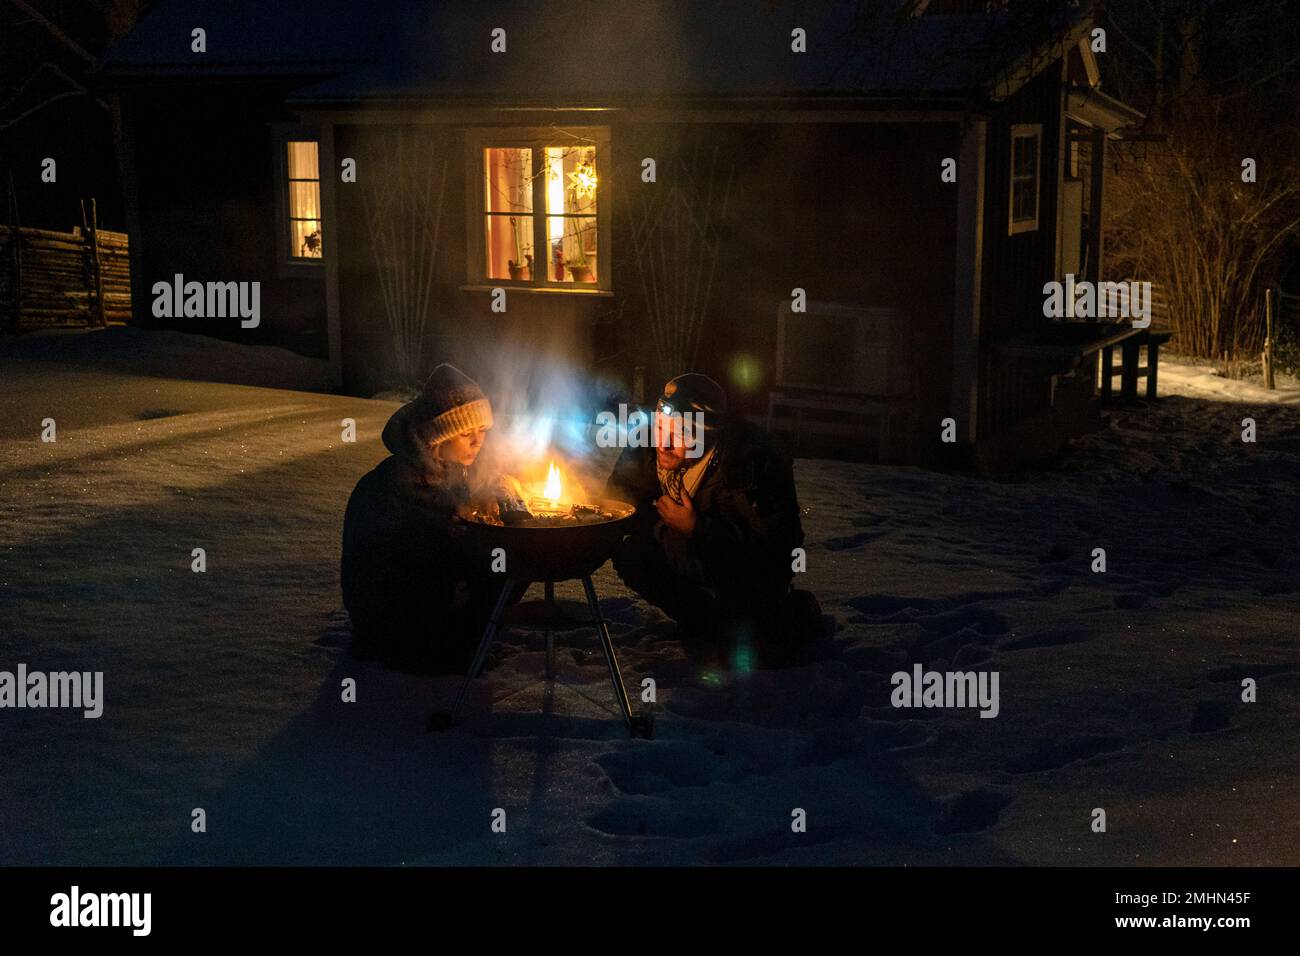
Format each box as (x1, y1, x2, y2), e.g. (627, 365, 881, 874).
(465, 499, 634, 581)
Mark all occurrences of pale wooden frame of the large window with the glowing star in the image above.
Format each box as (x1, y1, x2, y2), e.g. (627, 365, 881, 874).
(464, 126, 614, 295)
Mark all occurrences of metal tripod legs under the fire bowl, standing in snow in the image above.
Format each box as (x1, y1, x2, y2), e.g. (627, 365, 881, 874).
(429, 575, 654, 740)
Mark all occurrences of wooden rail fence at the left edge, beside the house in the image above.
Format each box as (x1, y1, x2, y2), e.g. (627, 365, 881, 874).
(0, 226, 131, 332)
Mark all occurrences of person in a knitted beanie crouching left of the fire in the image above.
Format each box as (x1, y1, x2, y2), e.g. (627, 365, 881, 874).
(341, 365, 512, 674)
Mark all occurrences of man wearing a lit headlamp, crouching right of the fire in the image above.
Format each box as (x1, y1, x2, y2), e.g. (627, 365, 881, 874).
(606, 373, 822, 670)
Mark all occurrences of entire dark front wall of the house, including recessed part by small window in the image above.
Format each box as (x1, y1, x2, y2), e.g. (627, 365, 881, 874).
(119, 87, 967, 463)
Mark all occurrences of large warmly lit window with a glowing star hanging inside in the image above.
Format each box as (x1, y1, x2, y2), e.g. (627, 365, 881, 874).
(471, 131, 608, 289)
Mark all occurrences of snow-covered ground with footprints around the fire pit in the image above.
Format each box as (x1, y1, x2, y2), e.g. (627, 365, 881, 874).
(0, 350, 1300, 865)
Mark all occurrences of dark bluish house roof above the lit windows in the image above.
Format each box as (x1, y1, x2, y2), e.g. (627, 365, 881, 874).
(100, 0, 1086, 107)
